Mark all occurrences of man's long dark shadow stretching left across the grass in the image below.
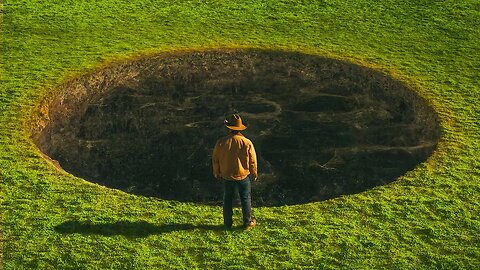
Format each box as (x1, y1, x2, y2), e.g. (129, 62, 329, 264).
(55, 221, 237, 238)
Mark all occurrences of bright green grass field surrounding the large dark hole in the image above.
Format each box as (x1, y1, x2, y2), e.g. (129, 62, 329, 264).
(0, 0, 480, 269)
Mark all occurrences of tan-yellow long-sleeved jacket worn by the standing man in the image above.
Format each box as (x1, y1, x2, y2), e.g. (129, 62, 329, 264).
(212, 133, 257, 181)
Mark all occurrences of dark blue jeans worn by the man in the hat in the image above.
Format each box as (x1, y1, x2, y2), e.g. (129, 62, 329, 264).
(223, 176, 252, 227)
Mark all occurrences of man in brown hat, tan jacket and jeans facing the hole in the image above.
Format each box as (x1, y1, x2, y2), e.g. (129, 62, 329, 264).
(212, 114, 257, 230)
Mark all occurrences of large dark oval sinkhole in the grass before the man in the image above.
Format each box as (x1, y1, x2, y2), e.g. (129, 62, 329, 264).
(33, 50, 440, 206)
